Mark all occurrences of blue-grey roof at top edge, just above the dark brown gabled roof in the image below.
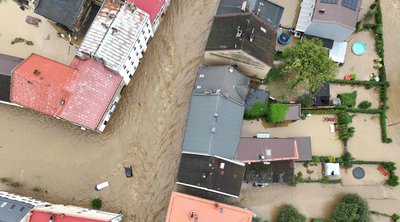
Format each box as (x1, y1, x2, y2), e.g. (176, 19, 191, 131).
(217, 0, 283, 29)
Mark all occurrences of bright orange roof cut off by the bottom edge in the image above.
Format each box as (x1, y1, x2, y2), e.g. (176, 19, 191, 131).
(166, 192, 253, 222)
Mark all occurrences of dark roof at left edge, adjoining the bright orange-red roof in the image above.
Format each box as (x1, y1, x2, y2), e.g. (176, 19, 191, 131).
(0, 54, 24, 102)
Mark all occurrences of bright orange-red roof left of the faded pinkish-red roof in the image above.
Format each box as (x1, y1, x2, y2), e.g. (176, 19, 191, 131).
(10, 54, 78, 116)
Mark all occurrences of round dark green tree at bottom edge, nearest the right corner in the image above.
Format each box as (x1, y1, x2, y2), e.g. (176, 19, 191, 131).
(333, 193, 371, 222)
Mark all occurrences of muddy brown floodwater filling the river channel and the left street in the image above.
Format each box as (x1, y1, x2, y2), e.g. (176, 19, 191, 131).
(0, 0, 218, 221)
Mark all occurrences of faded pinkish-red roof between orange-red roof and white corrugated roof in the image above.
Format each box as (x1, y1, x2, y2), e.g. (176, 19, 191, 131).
(59, 58, 122, 130)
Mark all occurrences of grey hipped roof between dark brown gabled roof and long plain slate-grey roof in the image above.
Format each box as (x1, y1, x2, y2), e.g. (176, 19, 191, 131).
(193, 66, 250, 104)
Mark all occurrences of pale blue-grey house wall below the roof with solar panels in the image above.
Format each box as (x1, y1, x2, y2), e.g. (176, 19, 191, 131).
(305, 21, 354, 42)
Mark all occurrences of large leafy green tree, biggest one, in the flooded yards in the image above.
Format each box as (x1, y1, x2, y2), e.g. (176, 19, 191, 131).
(282, 39, 337, 94)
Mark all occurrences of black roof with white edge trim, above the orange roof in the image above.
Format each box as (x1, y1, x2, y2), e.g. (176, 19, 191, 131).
(177, 153, 245, 197)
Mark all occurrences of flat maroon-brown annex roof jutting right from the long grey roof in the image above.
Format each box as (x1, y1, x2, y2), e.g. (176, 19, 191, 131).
(236, 137, 299, 162)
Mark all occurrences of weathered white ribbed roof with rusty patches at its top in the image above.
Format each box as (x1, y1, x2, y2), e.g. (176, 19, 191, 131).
(77, 0, 149, 72)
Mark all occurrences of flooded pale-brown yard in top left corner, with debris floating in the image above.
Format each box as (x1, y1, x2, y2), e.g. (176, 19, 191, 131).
(0, 0, 76, 65)
